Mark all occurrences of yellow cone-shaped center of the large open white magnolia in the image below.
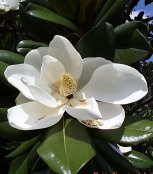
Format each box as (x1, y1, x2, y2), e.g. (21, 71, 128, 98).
(59, 72, 77, 98)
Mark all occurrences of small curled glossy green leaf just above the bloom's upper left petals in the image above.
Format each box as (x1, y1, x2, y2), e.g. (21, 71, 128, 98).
(16, 40, 47, 56)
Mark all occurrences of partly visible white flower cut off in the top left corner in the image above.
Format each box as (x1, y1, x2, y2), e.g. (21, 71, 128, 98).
(0, 0, 25, 13)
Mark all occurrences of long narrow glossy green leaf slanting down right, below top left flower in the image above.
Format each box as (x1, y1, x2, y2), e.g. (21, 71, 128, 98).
(27, 10, 79, 31)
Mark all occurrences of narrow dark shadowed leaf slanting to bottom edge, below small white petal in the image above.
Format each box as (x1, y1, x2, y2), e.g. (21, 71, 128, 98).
(94, 139, 137, 174)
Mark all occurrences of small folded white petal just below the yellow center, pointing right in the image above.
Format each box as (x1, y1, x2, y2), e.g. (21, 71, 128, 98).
(64, 98, 101, 120)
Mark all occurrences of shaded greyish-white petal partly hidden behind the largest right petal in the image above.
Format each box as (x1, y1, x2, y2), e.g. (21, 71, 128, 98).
(78, 57, 112, 89)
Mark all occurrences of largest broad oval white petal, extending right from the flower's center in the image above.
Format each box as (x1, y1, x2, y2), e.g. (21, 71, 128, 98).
(76, 63, 148, 104)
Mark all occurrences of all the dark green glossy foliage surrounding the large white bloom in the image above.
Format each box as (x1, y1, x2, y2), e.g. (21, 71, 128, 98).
(0, 0, 153, 174)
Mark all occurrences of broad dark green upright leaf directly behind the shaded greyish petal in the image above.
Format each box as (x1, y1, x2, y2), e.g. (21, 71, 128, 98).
(76, 23, 115, 60)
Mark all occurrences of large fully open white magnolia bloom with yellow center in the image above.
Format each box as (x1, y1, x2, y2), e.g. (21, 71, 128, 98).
(4, 35, 147, 130)
